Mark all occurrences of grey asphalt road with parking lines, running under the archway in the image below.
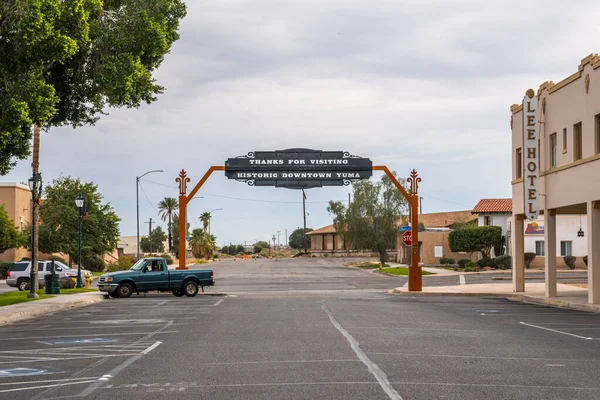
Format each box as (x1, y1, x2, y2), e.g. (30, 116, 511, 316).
(0, 260, 600, 400)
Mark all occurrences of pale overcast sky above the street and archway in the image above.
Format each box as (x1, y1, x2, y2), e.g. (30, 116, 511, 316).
(0, 0, 600, 245)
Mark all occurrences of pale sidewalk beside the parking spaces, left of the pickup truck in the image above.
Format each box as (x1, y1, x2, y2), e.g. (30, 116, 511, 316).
(0, 292, 104, 325)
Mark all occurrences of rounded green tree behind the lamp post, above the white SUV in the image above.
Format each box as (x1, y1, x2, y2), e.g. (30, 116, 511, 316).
(28, 177, 120, 261)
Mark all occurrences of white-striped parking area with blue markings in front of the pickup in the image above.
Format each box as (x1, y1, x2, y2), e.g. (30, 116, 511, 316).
(0, 295, 223, 399)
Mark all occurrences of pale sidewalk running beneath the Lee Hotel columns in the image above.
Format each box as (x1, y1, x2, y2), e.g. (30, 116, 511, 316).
(389, 283, 600, 312)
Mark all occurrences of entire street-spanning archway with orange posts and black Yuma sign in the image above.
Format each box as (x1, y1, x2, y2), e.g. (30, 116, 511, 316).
(176, 149, 423, 292)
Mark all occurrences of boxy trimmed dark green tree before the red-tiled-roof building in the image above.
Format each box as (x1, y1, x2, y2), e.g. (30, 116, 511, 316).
(448, 226, 502, 258)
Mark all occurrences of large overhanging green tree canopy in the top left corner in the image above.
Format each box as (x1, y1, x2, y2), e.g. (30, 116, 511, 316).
(0, 0, 186, 175)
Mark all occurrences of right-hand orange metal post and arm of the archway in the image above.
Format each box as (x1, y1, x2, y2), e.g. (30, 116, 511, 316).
(373, 166, 423, 292)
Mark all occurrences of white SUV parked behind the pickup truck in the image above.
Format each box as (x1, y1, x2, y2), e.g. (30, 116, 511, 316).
(6, 260, 92, 290)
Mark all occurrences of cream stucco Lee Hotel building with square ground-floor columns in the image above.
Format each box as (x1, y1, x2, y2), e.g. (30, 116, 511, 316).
(511, 54, 600, 304)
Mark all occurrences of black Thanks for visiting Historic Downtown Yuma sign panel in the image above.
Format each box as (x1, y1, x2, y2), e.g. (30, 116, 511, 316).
(225, 149, 373, 189)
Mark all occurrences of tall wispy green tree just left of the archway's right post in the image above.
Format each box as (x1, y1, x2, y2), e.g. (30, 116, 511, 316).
(327, 172, 408, 263)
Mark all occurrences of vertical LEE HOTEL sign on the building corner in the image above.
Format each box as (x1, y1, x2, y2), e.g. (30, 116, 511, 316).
(523, 89, 540, 220)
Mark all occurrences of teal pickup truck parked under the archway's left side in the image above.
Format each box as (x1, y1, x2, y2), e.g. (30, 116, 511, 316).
(98, 257, 215, 298)
